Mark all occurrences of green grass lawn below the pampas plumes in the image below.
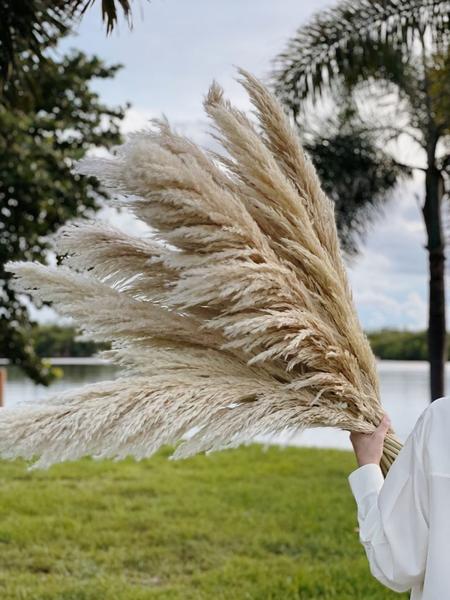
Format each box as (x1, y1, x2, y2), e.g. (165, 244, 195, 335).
(0, 445, 408, 600)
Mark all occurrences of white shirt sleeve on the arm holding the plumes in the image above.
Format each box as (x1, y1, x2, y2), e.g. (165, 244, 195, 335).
(348, 415, 429, 592)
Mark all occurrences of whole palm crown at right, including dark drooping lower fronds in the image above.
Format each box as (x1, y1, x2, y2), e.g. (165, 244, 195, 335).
(274, 0, 450, 253)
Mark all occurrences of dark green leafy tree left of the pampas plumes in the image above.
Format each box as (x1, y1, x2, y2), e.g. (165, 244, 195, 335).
(0, 40, 124, 384)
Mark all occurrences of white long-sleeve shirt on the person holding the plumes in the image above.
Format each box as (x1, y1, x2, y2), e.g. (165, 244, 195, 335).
(348, 397, 450, 600)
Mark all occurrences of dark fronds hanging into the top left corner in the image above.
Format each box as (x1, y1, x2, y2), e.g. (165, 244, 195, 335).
(0, 0, 135, 79)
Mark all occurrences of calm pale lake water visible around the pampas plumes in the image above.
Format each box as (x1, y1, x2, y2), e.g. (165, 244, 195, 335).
(5, 359, 450, 448)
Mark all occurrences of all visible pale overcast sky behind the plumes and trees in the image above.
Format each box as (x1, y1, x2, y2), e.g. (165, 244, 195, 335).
(56, 0, 450, 329)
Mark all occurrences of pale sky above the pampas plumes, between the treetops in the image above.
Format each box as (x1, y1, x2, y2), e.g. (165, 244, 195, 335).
(61, 0, 335, 120)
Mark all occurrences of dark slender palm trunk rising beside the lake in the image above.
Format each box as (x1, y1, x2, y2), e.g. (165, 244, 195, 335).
(423, 161, 447, 401)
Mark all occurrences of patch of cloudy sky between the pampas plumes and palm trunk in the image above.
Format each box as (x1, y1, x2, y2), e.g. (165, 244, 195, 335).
(349, 178, 450, 329)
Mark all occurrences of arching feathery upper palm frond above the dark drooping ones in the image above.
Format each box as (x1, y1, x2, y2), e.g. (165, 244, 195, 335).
(274, 0, 450, 106)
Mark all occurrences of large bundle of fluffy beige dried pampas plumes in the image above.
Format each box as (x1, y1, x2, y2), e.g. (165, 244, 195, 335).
(0, 70, 401, 473)
